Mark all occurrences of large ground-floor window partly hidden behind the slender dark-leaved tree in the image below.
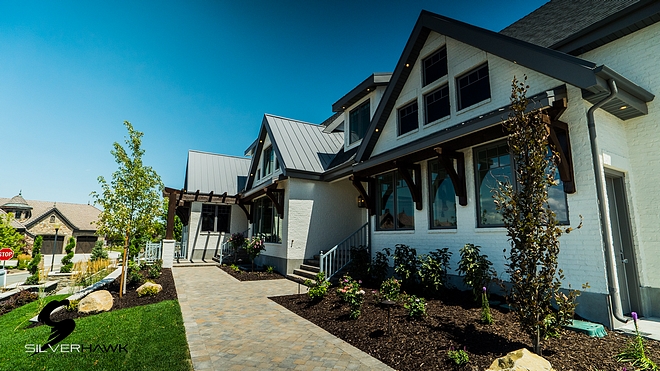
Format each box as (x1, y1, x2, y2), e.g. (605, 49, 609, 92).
(474, 142, 569, 227)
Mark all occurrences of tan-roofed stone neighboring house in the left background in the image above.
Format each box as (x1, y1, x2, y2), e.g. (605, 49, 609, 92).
(0, 193, 102, 254)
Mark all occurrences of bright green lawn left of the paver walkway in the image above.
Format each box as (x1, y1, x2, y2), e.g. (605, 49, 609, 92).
(0, 295, 192, 371)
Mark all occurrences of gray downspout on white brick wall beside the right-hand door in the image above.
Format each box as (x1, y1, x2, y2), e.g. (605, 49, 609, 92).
(587, 80, 628, 327)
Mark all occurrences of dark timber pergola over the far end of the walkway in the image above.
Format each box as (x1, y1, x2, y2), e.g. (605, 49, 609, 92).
(163, 187, 240, 240)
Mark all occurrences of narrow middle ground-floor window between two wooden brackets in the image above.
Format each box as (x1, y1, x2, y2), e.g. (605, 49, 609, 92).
(429, 160, 456, 229)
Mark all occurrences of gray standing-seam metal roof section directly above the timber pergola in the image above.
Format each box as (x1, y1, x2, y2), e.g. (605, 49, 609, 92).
(183, 150, 250, 195)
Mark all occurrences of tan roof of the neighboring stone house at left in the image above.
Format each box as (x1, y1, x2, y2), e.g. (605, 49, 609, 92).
(0, 198, 101, 231)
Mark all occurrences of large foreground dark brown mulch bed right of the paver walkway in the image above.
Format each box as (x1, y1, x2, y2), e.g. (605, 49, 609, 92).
(271, 289, 660, 371)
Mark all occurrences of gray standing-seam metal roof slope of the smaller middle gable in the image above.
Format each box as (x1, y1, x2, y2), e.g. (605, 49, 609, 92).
(264, 115, 344, 173)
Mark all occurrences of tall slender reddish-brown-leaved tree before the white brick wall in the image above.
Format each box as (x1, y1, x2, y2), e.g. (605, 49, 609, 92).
(493, 77, 579, 355)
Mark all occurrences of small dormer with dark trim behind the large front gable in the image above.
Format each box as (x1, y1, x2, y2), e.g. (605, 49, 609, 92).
(323, 73, 392, 151)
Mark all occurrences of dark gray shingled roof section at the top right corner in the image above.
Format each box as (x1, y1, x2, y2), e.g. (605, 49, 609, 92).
(500, 0, 639, 48)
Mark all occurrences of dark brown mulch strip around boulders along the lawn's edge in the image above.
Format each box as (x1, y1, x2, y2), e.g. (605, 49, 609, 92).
(33, 268, 177, 326)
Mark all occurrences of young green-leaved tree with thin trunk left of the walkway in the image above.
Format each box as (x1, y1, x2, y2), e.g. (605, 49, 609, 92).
(92, 121, 163, 293)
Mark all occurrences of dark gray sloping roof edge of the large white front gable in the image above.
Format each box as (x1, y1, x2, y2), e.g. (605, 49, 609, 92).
(356, 10, 654, 162)
